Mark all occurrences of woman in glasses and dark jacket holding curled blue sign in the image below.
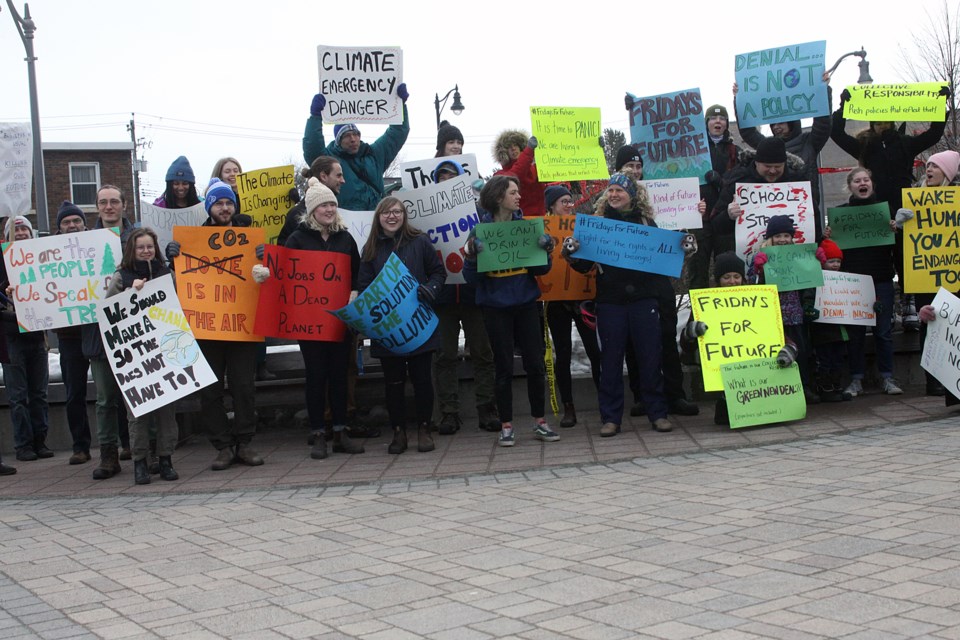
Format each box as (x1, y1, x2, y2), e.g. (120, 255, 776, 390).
(357, 196, 447, 454)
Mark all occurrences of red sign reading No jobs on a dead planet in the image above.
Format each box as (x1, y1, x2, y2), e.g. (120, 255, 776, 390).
(254, 244, 351, 342)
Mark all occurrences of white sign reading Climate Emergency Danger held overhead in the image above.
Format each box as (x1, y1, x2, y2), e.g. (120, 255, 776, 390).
(317, 45, 403, 124)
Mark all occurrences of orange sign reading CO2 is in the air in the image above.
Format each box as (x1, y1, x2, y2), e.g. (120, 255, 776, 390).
(173, 227, 264, 342)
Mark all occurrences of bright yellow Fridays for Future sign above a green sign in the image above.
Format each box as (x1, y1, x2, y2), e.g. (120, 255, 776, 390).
(690, 285, 783, 391)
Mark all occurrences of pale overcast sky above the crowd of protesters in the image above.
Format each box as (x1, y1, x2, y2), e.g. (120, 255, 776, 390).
(0, 0, 941, 199)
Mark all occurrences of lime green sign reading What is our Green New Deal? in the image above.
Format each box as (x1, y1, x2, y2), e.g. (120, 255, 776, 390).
(720, 358, 807, 429)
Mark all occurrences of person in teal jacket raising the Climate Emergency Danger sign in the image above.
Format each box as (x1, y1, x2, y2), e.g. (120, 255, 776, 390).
(303, 83, 410, 211)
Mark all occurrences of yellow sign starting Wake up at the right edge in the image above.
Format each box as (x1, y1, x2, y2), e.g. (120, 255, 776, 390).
(903, 187, 960, 293)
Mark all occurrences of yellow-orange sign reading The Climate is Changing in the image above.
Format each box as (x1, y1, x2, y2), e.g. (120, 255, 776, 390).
(237, 164, 296, 244)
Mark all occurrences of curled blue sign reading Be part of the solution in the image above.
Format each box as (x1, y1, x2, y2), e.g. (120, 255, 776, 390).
(331, 253, 438, 354)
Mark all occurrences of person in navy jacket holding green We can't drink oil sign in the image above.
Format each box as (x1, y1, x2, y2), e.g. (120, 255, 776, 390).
(463, 174, 560, 447)
